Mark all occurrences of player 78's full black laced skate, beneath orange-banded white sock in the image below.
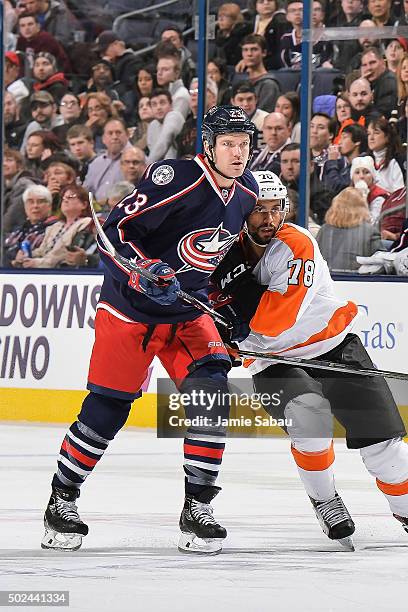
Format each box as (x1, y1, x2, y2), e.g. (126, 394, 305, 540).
(310, 493, 355, 551)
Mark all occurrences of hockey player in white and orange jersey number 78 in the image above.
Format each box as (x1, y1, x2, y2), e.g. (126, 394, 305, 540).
(212, 172, 408, 550)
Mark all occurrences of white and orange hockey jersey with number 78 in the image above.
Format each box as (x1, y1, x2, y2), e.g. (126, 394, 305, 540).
(239, 223, 357, 374)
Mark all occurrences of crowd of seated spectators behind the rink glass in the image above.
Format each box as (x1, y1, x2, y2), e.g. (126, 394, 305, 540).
(1, 0, 408, 272)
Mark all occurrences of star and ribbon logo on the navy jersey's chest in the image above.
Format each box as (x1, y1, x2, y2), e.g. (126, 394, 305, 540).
(177, 223, 238, 274)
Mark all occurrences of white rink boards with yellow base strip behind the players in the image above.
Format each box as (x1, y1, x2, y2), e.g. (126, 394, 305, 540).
(0, 273, 408, 433)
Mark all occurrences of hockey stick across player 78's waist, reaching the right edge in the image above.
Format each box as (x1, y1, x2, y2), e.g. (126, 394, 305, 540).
(237, 351, 408, 380)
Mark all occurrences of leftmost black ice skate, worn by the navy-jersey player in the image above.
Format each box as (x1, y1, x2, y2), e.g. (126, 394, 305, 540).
(41, 488, 88, 550)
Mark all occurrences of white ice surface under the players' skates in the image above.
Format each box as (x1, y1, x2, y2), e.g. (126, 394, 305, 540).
(0, 424, 408, 612)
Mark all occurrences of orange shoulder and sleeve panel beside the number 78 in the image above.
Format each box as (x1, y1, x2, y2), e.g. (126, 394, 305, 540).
(250, 226, 314, 336)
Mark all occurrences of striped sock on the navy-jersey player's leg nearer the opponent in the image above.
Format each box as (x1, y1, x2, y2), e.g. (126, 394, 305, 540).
(184, 429, 225, 494)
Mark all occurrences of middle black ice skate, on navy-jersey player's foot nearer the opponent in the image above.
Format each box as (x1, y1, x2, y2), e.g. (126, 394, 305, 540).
(178, 487, 227, 554)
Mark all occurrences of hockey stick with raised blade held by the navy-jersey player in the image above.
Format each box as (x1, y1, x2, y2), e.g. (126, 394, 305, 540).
(88, 192, 231, 329)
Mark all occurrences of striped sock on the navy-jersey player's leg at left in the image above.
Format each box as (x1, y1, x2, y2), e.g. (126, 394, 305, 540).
(52, 421, 109, 489)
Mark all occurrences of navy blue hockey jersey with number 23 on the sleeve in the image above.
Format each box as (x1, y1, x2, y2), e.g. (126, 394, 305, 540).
(98, 155, 258, 323)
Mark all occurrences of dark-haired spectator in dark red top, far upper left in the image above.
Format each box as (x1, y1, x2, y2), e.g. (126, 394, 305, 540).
(17, 13, 71, 72)
